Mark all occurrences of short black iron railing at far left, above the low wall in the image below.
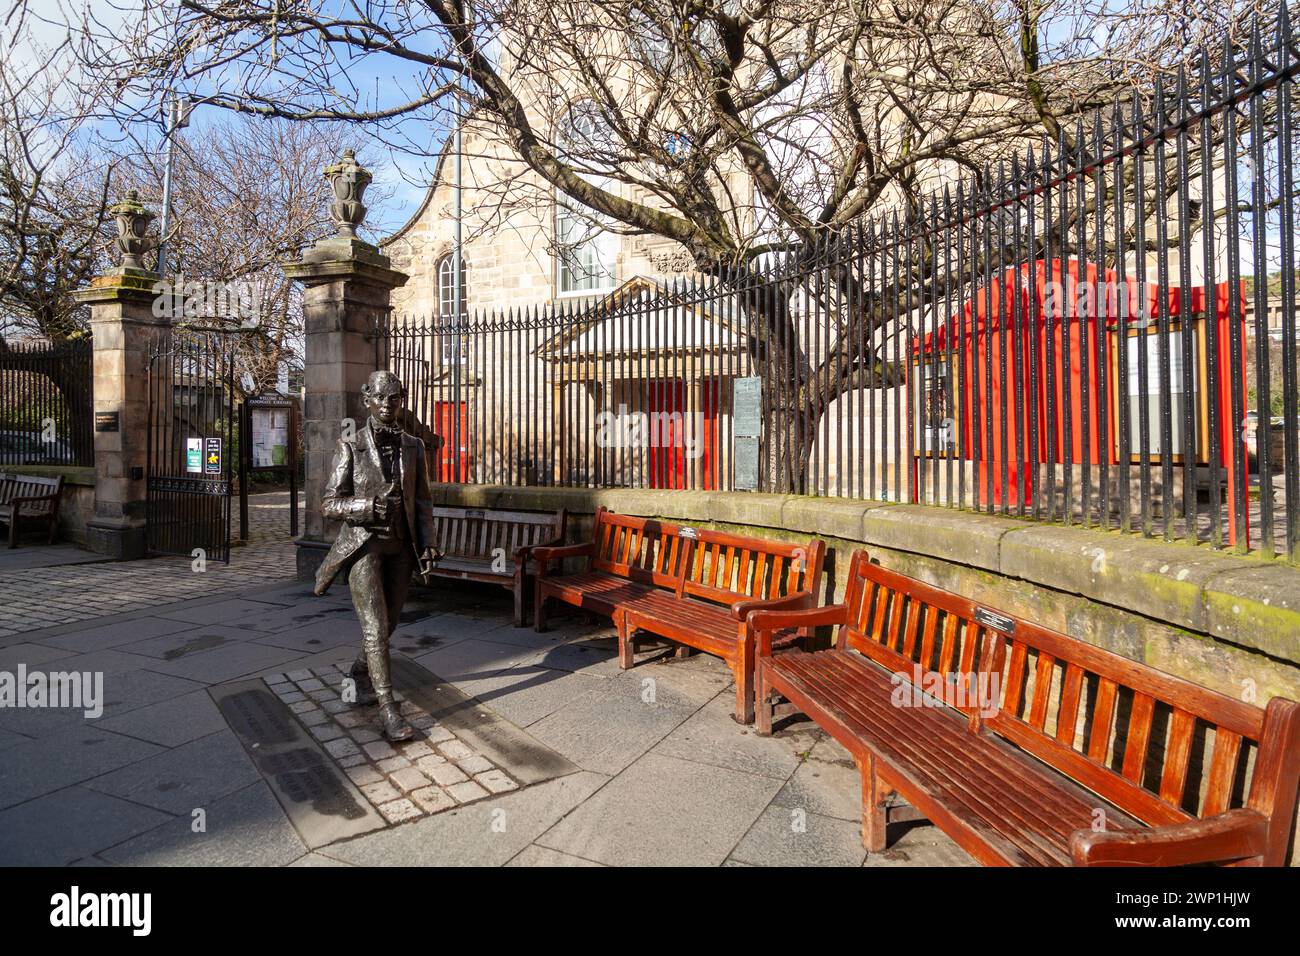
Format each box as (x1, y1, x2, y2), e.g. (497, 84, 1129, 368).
(0, 338, 95, 470)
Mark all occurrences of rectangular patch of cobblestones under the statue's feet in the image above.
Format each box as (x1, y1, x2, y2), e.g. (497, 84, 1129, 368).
(264, 665, 519, 823)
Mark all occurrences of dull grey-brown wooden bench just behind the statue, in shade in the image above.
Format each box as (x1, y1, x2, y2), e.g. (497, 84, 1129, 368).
(423, 507, 564, 627)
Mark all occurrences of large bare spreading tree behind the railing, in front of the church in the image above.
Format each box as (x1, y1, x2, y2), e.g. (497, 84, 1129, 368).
(71, 0, 1268, 490)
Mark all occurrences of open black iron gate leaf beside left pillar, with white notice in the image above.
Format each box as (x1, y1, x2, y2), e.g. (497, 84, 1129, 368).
(146, 332, 235, 562)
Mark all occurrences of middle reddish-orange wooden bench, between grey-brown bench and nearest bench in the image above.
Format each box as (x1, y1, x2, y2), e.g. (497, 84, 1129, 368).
(533, 507, 826, 723)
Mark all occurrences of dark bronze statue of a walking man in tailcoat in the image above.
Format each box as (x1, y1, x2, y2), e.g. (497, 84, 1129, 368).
(316, 372, 442, 740)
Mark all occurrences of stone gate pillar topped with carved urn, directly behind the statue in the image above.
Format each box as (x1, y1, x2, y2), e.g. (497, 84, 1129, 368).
(285, 150, 407, 580)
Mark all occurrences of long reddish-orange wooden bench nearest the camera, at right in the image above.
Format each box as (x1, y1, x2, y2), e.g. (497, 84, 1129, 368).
(751, 551, 1300, 866)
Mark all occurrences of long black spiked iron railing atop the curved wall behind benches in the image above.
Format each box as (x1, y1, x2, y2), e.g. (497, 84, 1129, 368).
(377, 13, 1300, 559)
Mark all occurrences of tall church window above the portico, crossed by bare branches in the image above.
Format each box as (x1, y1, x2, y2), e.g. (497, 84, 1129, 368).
(555, 100, 619, 294)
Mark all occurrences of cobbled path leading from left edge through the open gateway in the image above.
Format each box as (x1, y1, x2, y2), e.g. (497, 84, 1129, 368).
(0, 492, 295, 637)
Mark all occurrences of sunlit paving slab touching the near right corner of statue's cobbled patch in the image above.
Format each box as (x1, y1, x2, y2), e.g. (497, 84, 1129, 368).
(321, 771, 608, 866)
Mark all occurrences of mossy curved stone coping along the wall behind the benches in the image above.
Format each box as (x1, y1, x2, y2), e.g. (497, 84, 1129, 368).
(433, 484, 1300, 663)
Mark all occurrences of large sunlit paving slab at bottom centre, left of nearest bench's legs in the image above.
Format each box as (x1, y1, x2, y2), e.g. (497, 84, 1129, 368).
(537, 753, 781, 866)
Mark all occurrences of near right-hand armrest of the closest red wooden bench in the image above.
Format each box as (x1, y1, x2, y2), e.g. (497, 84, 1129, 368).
(1070, 809, 1269, 866)
